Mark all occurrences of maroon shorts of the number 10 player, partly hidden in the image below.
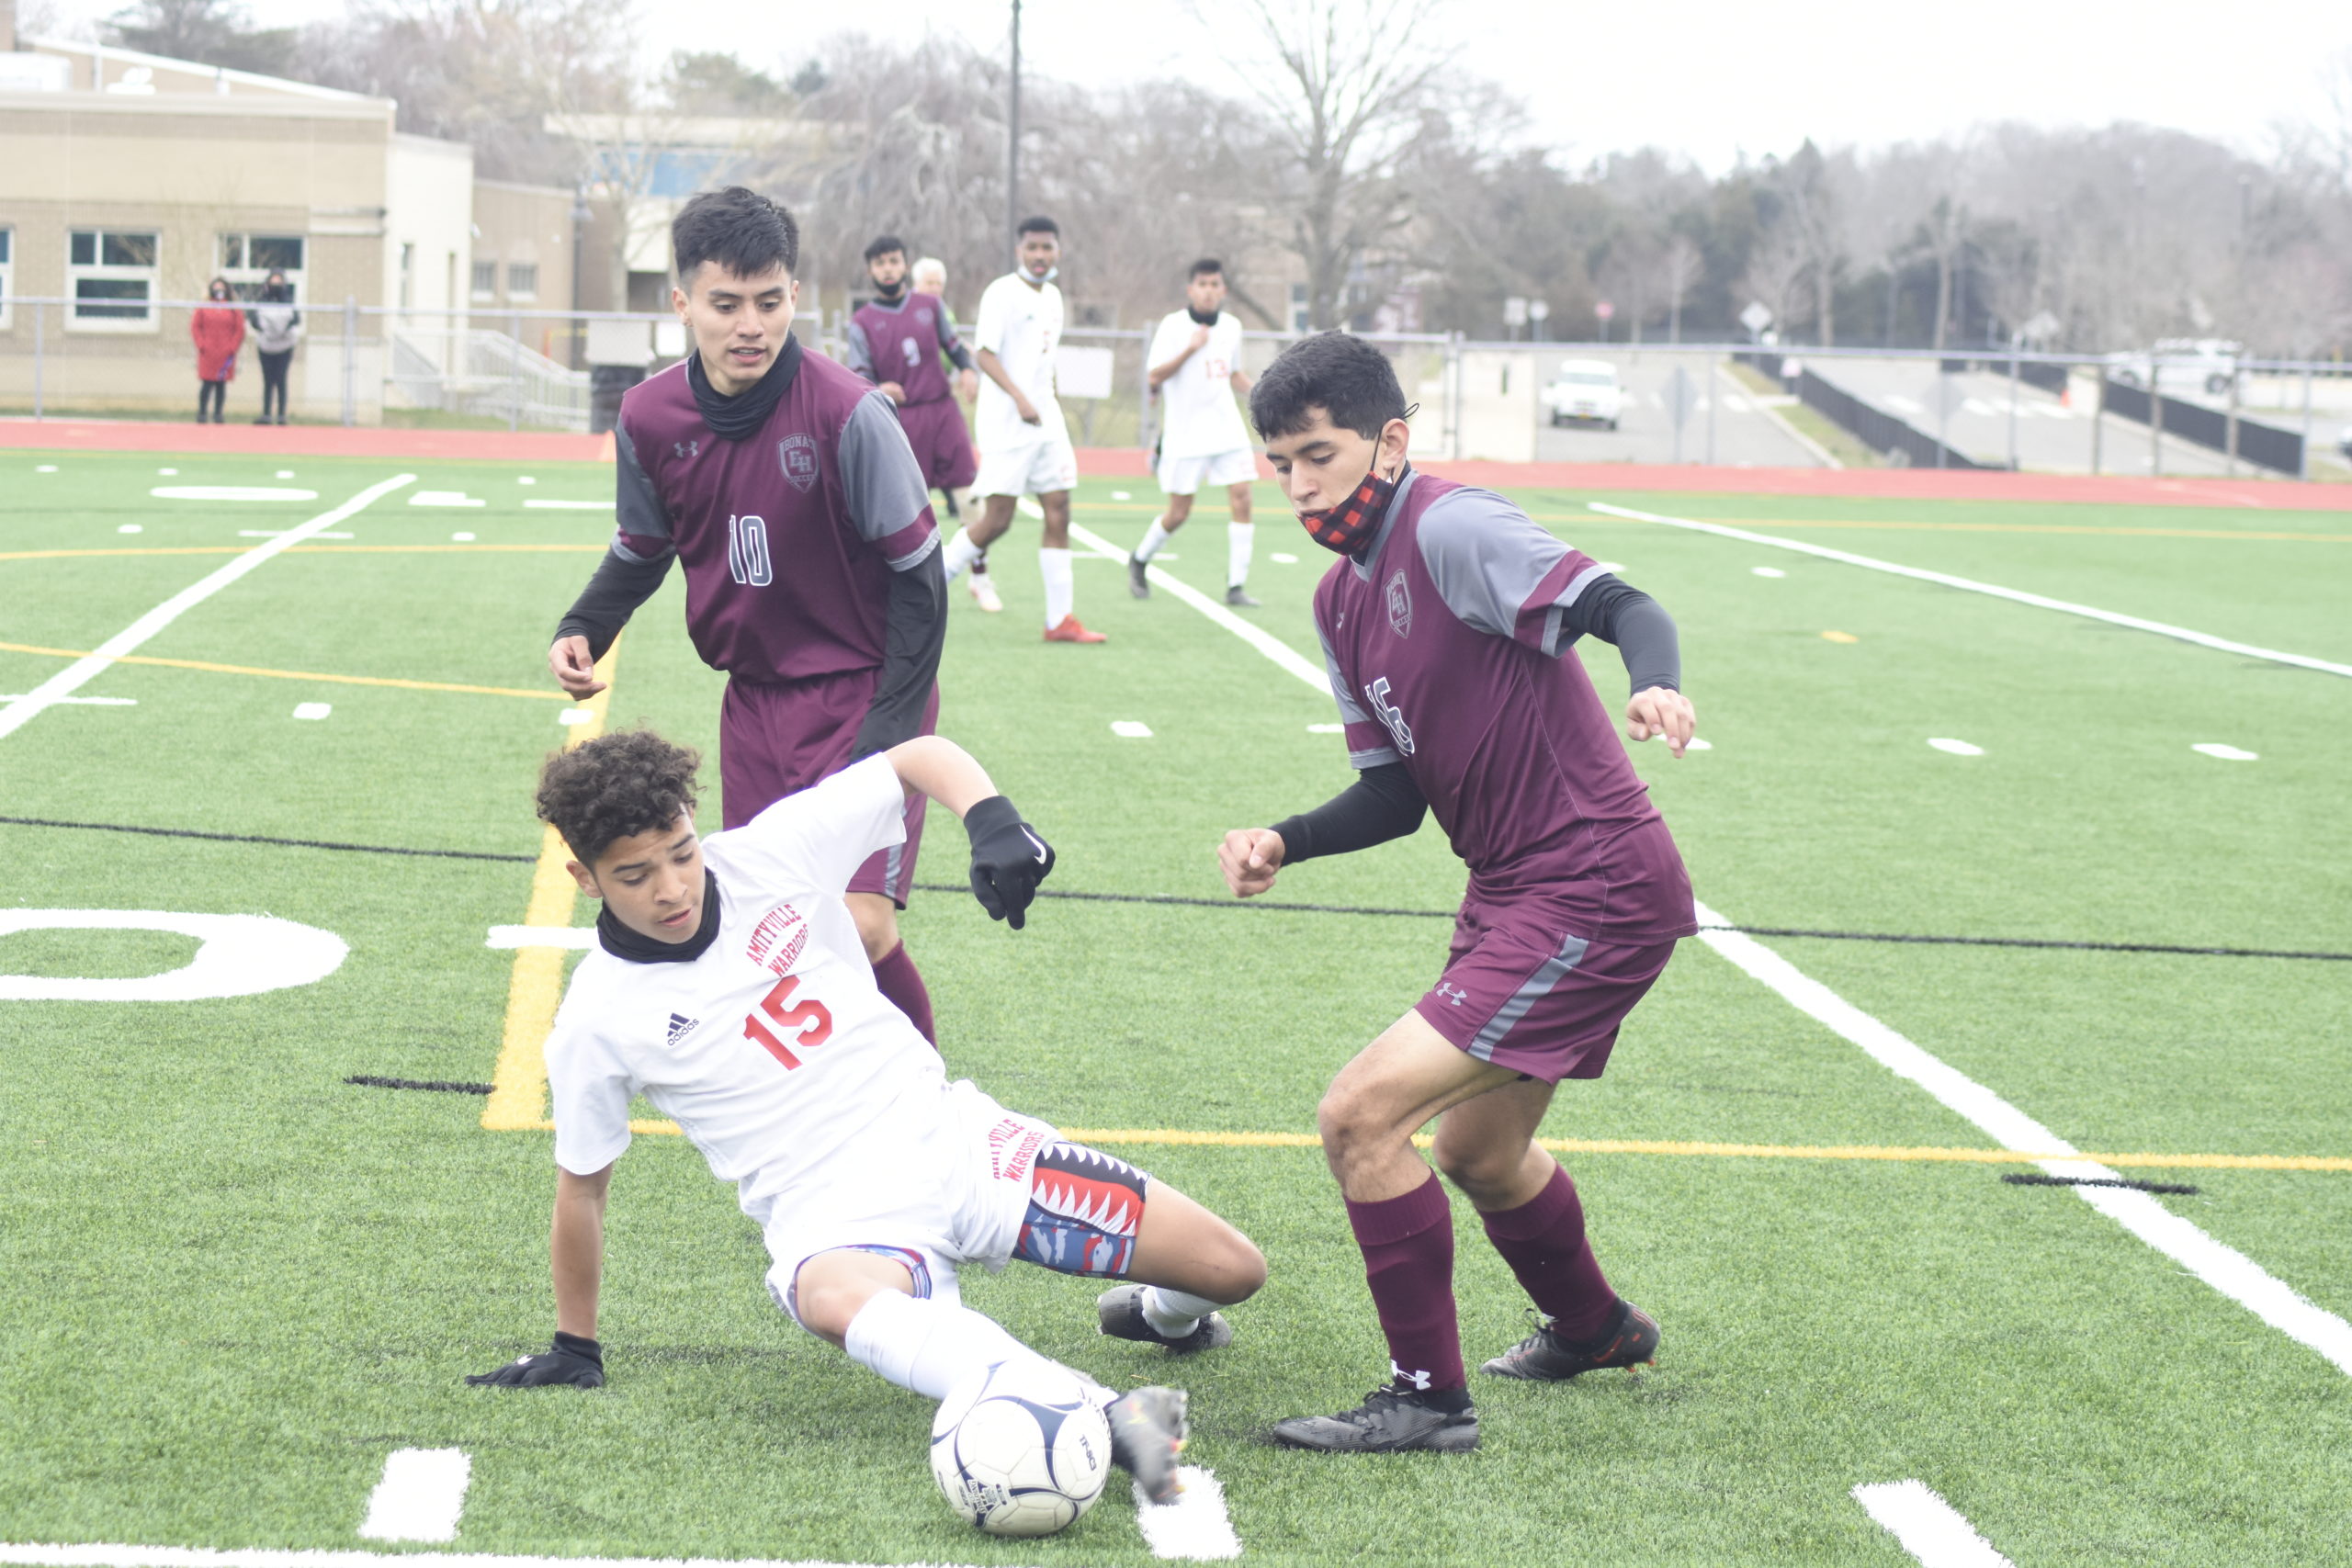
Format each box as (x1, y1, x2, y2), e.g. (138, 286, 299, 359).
(719, 670, 938, 909)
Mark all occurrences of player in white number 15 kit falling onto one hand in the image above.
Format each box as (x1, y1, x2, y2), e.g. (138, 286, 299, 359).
(468, 731, 1265, 1502)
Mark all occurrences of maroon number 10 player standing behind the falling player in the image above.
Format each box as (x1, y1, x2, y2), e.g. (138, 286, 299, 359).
(548, 186, 948, 1039)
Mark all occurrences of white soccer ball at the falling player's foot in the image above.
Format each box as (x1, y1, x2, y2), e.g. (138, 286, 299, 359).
(932, 1361, 1110, 1535)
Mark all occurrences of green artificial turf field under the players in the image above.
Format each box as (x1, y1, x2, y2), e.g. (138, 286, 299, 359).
(0, 451, 2352, 1568)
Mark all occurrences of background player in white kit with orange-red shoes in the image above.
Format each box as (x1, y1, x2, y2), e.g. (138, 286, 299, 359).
(941, 219, 1103, 642)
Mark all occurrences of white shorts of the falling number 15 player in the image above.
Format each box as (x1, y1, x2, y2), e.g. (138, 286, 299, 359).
(764, 1079, 1061, 1324)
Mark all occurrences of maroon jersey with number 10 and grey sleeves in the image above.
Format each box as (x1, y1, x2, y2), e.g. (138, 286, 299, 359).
(614, 353, 938, 682)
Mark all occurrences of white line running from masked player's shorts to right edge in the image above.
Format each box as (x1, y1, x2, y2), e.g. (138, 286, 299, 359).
(1698, 905, 2352, 1373)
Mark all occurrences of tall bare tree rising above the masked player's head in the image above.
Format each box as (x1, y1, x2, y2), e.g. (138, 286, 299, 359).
(1242, 0, 1453, 327)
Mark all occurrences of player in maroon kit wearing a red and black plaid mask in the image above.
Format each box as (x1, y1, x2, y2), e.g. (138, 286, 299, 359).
(1218, 332, 1696, 1453)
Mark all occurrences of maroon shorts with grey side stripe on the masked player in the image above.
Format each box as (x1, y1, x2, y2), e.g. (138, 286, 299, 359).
(1414, 900, 1675, 1084)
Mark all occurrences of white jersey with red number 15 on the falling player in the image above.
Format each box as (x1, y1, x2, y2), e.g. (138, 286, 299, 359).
(548, 757, 967, 1229)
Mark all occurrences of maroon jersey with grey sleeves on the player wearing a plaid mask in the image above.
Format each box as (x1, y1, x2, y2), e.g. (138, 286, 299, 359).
(1315, 472, 1696, 942)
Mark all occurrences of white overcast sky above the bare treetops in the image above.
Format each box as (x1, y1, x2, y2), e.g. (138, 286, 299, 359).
(86, 0, 2352, 174)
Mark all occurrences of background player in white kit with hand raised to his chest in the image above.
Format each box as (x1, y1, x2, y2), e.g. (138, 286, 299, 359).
(1126, 256, 1259, 604)
